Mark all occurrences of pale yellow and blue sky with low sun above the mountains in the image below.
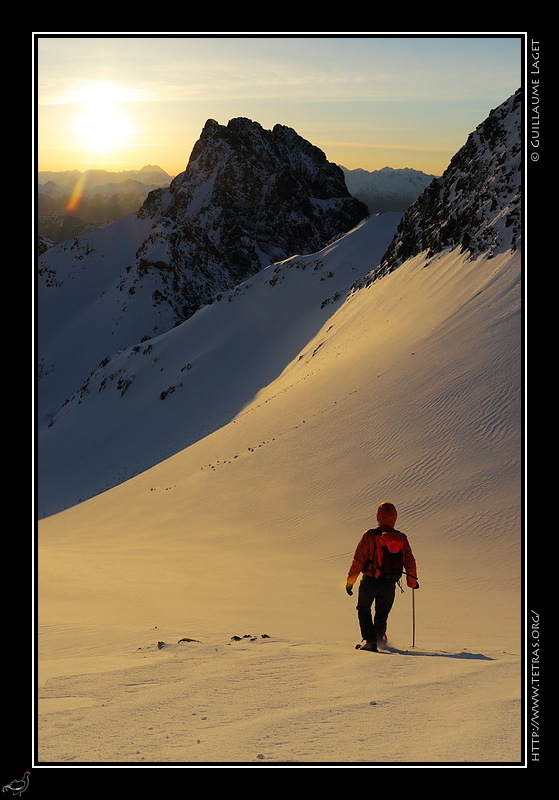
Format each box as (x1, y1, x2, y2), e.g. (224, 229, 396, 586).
(33, 32, 525, 175)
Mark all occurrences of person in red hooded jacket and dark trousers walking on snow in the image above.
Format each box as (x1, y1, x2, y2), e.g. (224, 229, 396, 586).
(346, 503, 419, 652)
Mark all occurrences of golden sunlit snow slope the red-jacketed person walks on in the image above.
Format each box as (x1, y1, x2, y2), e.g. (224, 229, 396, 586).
(37, 222, 522, 767)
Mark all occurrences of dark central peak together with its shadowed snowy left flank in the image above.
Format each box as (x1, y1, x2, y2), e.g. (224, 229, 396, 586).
(38, 119, 367, 418)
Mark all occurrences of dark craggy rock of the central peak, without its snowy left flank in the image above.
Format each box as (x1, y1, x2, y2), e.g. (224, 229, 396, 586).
(139, 117, 368, 304)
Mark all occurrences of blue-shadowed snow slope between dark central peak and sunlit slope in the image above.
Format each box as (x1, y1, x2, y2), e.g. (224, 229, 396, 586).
(39, 214, 401, 515)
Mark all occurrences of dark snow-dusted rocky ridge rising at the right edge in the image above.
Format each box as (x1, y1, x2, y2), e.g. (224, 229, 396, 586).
(374, 89, 522, 277)
